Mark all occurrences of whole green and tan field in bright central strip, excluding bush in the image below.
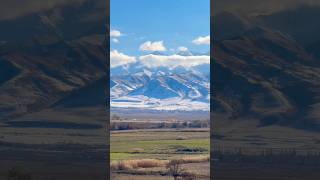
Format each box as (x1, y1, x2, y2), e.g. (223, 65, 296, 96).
(110, 129, 210, 180)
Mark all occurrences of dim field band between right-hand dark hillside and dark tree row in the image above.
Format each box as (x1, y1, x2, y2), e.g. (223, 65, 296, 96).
(211, 116, 320, 153)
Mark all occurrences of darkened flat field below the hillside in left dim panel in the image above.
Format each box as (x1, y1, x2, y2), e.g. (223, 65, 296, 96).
(0, 108, 108, 180)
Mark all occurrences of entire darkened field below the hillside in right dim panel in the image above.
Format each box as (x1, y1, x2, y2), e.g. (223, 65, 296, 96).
(211, 114, 320, 180)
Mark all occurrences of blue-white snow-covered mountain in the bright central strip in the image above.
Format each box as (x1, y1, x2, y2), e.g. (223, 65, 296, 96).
(110, 63, 210, 111)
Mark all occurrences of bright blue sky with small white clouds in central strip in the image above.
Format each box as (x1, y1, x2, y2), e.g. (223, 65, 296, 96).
(110, 0, 210, 68)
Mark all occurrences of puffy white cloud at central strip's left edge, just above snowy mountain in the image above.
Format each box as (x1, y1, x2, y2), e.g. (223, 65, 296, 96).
(110, 50, 136, 68)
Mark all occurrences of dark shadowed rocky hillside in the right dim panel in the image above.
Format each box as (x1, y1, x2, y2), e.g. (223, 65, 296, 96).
(211, 9, 320, 130)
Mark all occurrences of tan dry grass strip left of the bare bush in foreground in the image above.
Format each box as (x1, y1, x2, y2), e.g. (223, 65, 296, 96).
(111, 159, 169, 170)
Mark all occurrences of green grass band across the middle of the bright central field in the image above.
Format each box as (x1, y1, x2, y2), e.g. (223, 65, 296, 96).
(110, 132, 210, 160)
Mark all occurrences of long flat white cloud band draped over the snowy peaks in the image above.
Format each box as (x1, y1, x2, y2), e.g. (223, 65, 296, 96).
(139, 54, 210, 68)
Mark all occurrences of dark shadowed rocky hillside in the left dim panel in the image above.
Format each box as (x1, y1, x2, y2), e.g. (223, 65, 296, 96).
(0, 0, 107, 119)
